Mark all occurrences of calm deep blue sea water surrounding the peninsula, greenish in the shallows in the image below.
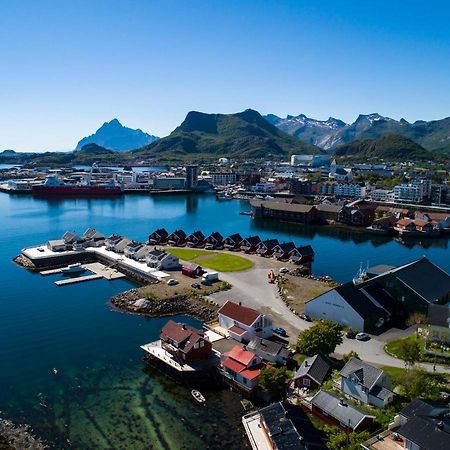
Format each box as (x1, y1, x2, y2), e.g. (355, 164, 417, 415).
(0, 193, 450, 449)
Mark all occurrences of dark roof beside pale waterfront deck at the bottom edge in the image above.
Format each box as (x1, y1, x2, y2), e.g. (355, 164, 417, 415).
(259, 402, 306, 450)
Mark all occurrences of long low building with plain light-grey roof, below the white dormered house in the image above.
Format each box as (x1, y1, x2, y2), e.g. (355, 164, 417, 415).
(311, 391, 375, 431)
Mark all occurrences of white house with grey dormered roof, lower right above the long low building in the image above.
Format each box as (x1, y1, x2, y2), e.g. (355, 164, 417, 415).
(339, 358, 394, 408)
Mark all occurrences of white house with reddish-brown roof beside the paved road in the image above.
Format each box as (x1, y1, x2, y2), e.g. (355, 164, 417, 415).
(218, 300, 272, 342)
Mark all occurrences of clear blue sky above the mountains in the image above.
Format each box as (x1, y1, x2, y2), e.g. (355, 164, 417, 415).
(0, 0, 450, 151)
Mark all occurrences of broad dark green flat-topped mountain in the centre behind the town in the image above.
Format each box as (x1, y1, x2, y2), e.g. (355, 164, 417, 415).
(135, 109, 323, 159)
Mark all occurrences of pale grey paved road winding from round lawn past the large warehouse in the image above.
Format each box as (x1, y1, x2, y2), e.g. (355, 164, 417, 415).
(211, 268, 450, 373)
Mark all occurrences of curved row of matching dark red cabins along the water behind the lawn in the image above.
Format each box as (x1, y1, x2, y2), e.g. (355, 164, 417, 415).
(148, 228, 314, 264)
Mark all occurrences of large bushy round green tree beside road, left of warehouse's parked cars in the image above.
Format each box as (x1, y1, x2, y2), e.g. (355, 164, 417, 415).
(297, 320, 342, 356)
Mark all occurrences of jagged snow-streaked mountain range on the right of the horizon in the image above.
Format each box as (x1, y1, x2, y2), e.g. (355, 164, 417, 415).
(264, 113, 450, 152)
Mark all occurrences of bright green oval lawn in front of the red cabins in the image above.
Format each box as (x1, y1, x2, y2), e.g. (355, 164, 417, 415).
(167, 248, 253, 272)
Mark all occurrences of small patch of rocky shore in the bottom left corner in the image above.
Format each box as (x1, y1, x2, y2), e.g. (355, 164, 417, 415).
(0, 413, 49, 450)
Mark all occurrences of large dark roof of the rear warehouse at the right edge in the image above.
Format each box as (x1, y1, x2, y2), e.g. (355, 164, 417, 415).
(368, 257, 450, 303)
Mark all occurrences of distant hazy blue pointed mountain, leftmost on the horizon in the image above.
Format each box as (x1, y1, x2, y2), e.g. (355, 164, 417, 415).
(75, 119, 158, 152)
